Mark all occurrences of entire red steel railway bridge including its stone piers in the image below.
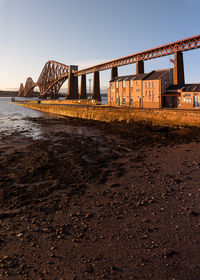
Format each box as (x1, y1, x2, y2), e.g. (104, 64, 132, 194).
(18, 35, 200, 101)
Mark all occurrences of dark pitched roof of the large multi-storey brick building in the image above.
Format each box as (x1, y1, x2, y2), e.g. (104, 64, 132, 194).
(110, 69, 170, 82)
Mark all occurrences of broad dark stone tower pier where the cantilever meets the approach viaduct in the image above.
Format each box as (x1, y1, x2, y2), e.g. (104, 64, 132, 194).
(67, 66, 79, 99)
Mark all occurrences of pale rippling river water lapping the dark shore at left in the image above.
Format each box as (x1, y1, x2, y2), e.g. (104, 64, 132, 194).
(0, 97, 106, 140)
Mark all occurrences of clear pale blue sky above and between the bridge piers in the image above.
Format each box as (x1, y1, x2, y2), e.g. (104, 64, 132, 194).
(0, 0, 200, 89)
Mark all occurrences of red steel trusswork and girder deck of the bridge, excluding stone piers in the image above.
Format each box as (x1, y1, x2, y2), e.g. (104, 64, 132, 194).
(18, 35, 200, 98)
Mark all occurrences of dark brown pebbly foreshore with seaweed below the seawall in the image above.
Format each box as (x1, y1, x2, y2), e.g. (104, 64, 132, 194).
(0, 118, 200, 280)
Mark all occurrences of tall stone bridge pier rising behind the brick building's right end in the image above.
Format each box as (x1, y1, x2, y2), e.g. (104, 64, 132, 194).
(174, 51, 185, 85)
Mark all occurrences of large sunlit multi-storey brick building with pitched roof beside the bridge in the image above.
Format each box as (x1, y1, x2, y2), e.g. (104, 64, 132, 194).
(108, 69, 173, 108)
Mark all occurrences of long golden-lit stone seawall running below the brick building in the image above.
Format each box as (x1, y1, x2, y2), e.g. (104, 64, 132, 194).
(16, 102, 200, 127)
